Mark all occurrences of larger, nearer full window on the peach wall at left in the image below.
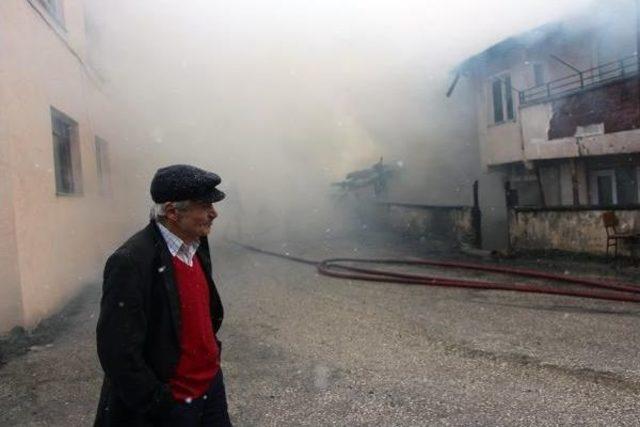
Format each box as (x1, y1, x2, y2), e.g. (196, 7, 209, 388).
(51, 108, 82, 195)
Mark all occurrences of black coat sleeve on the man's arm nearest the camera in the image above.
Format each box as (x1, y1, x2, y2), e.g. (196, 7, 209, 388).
(97, 251, 175, 417)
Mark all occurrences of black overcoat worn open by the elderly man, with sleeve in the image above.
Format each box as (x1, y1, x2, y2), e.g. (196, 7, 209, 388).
(95, 221, 223, 426)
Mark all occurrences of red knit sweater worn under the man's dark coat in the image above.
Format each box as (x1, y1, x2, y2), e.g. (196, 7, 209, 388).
(169, 256, 220, 401)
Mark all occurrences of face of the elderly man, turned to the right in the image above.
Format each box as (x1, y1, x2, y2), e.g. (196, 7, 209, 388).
(167, 201, 218, 242)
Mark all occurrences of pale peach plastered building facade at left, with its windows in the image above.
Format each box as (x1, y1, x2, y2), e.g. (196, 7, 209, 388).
(0, 0, 141, 333)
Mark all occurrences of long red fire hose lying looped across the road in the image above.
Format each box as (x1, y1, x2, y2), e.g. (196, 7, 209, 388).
(232, 241, 640, 303)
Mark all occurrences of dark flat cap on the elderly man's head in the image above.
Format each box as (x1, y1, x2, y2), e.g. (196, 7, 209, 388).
(151, 165, 225, 203)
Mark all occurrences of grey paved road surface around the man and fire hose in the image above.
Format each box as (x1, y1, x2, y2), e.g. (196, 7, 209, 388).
(0, 235, 640, 426)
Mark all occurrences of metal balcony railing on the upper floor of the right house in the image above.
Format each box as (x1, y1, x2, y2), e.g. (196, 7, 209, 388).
(519, 55, 638, 105)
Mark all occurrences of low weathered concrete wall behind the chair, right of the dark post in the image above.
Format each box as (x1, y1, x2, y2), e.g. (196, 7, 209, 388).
(509, 209, 640, 256)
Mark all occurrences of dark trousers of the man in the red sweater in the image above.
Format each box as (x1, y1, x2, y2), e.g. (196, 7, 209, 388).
(161, 370, 231, 427)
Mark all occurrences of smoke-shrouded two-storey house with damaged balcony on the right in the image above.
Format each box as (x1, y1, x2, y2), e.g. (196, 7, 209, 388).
(460, 0, 640, 252)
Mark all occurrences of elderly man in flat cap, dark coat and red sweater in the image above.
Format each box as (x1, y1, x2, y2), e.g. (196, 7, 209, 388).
(95, 165, 231, 426)
